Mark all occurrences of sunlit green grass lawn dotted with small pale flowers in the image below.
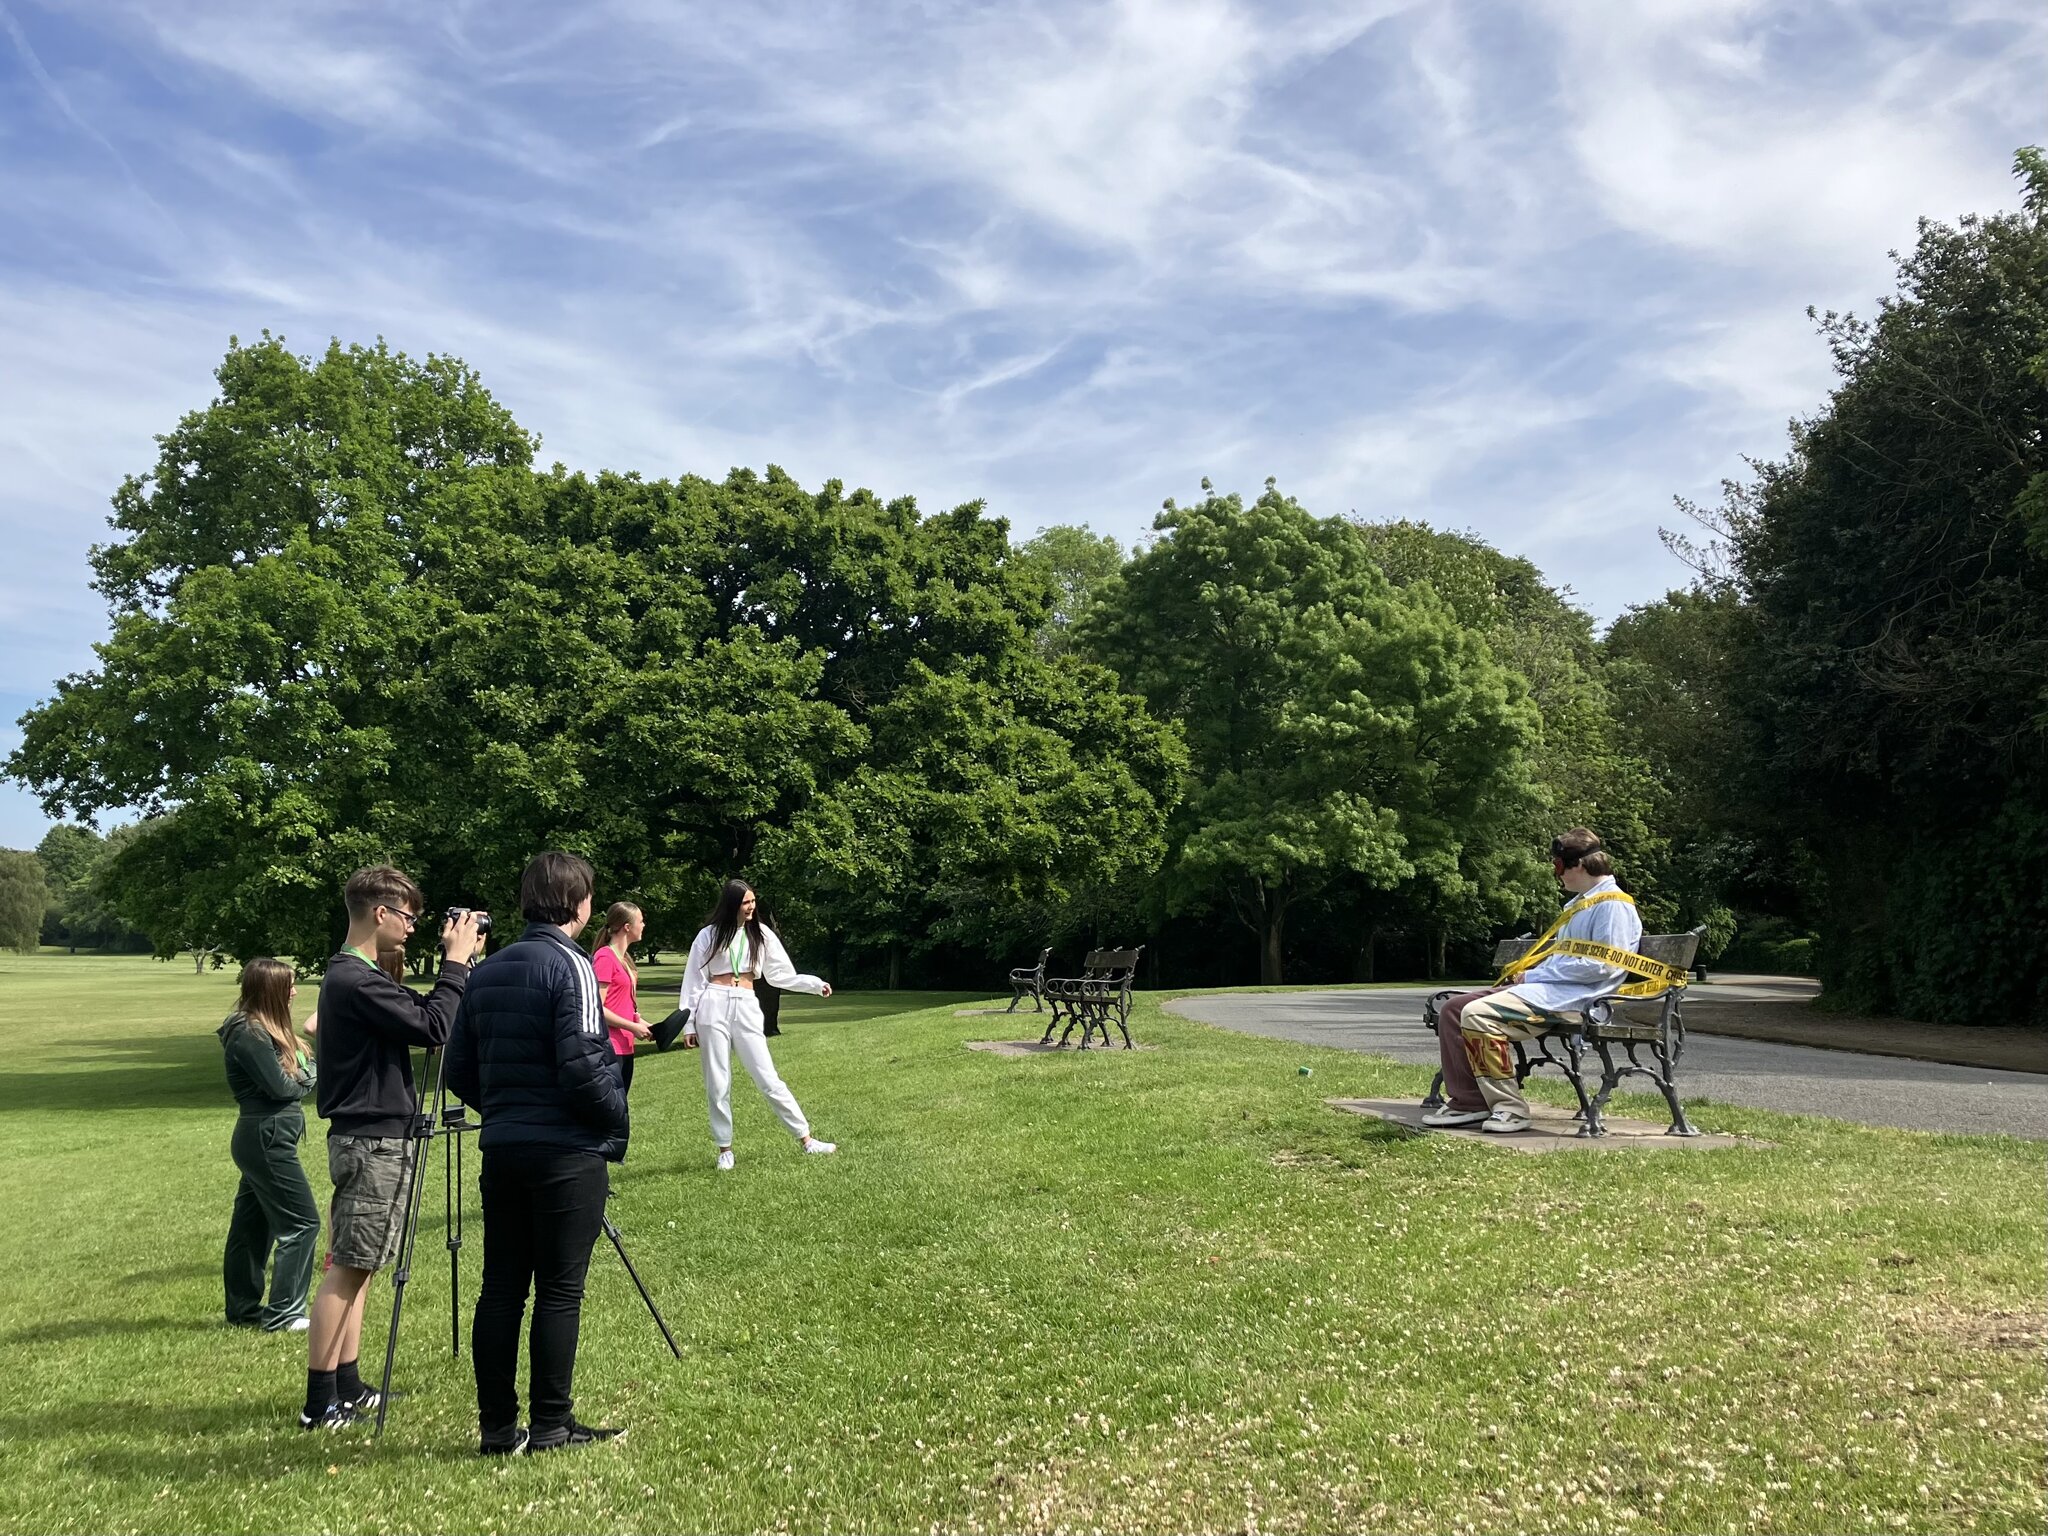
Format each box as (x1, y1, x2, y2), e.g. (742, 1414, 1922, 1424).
(0, 954, 2048, 1532)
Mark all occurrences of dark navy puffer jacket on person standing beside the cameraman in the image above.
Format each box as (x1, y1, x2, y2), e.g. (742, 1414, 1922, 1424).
(449, 924, 627, 1163)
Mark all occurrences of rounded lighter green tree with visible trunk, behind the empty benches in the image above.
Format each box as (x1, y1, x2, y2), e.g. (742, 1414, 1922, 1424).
(1079, 481, 1534, 983)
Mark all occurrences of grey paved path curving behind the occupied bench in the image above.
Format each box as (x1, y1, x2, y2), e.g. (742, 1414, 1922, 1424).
(1167, 987, 2048, 1141)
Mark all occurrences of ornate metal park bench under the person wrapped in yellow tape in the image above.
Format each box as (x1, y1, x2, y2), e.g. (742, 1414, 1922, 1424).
(1421, 928, 1706, 1137)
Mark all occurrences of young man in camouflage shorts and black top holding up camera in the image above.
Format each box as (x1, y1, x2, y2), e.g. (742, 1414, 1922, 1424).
(299, 864, 483, 1430)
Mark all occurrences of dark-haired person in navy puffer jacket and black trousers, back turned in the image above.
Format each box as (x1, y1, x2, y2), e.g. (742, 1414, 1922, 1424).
(449, 852, 627, 1456)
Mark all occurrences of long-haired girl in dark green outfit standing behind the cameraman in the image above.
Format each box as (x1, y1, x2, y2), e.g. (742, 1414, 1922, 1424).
(217, 958, 319, 1333)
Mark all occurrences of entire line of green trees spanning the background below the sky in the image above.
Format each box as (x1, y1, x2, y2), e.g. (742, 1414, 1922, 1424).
(6, 152, 2048, 1018)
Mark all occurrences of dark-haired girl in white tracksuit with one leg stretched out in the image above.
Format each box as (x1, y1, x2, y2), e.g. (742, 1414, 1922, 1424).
(682, 881, 838, 1169)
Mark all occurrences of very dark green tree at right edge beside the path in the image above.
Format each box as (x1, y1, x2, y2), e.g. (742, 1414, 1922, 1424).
(1731, 152, 2048, 1022)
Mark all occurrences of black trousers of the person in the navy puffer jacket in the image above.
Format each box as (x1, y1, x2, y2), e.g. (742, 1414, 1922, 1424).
(469, 1147, 606, 1440)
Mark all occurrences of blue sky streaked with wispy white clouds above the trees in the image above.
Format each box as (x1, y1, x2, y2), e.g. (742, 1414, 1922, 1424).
(0, 0, 2048, 846)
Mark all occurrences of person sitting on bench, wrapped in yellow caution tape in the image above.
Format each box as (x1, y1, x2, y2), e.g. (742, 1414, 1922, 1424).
(1421, 827, 1642, 1133)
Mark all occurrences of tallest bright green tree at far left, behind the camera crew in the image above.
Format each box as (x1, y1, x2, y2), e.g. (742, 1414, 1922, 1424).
(8, 336, 532, 958)
